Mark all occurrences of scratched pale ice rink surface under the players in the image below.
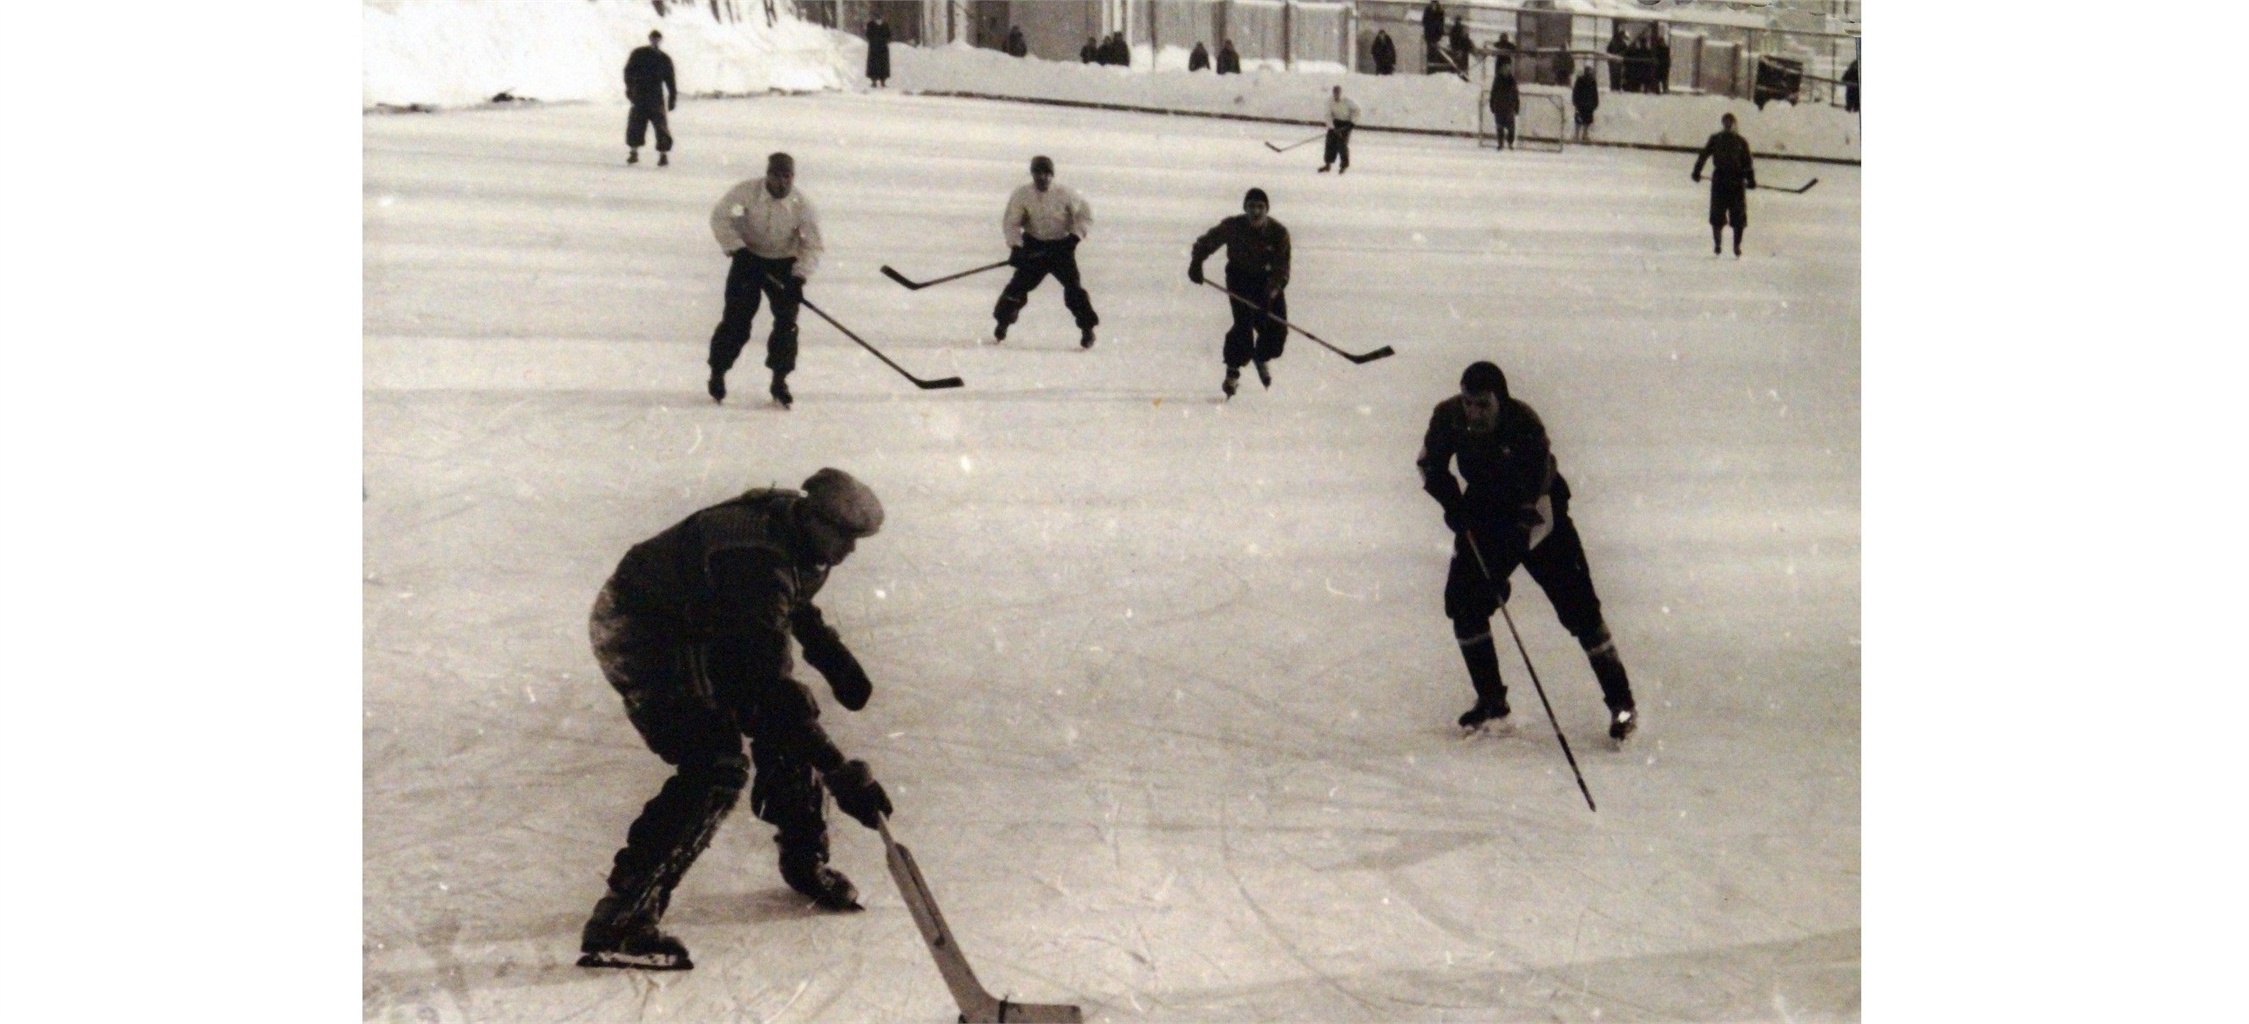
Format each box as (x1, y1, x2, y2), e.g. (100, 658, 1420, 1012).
(362, 95, 1860, 1022)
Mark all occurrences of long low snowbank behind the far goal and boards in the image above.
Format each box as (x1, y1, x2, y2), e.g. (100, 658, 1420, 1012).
(881, 43, 1860, 160)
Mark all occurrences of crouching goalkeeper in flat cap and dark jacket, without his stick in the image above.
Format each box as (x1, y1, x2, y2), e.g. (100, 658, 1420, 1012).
(578, 468, 891, 970)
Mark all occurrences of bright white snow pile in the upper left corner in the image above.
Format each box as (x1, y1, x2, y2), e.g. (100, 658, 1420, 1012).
(360, 0, 859, 108)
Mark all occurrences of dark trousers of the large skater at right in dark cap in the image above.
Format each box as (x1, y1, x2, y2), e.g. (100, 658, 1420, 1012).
(1444, 502, 1633, 709)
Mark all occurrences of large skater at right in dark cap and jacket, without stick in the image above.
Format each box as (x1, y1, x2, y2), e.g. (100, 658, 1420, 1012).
(1415, 362, 1640, 743)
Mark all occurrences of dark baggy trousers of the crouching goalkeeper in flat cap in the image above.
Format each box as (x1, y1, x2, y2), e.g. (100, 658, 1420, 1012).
(591, 587, 828, 923)
